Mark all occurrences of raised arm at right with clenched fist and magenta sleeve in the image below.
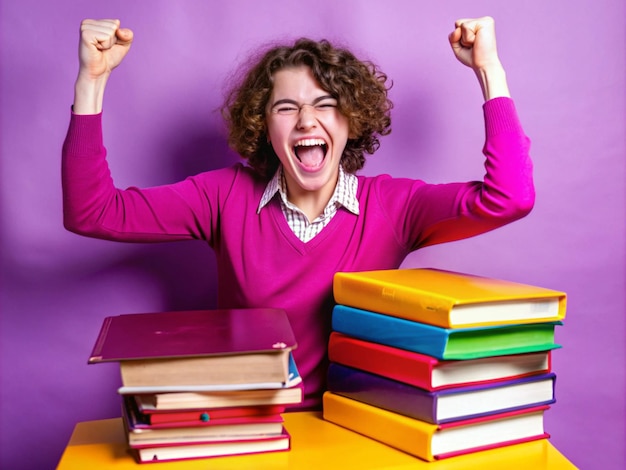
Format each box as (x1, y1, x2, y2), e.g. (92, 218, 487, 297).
(387, 17, 535, 249)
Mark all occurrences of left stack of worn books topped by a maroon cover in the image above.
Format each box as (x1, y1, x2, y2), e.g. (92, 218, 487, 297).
(88, 309, 303, 462)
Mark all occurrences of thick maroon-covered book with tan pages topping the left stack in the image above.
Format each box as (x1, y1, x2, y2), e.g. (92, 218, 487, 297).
(88, 309, 296, 388)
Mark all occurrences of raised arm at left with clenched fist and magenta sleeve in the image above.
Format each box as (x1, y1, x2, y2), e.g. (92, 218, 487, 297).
(62, 20, 220, 242)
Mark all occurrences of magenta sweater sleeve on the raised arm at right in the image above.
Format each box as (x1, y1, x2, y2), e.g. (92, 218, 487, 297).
(381, 98, 535, 250)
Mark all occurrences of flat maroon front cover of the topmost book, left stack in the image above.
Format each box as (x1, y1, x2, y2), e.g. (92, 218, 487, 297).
(89, 309, 296, 363)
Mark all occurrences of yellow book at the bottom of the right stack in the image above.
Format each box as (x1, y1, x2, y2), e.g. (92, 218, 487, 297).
(323, 392, 549, 462)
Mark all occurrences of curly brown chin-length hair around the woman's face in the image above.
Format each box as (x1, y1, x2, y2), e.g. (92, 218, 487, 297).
(221, 38, 393, 178)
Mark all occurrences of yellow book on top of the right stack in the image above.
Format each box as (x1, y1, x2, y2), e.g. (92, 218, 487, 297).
(333, 268, 566, 328)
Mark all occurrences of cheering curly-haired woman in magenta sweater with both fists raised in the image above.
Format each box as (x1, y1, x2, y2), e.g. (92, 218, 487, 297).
(63, 17, 534, 409)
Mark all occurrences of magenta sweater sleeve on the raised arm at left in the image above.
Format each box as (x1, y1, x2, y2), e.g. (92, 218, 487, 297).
(61, 110, 233, 242)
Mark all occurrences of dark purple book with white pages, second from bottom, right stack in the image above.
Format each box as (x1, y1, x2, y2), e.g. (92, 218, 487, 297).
(328, 363, 556, 424)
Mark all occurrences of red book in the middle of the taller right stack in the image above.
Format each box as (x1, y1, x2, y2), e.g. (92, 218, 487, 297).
(328, 332, 551, 391)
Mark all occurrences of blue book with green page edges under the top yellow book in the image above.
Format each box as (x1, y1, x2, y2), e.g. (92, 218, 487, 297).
(332, 305, 562, 359)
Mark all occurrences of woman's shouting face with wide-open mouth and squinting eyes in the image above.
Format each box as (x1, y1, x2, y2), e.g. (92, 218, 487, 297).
(267, 66, 349, 205)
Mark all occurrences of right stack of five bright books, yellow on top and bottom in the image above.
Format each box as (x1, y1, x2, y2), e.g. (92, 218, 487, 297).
(324, 268, 566, 461)
